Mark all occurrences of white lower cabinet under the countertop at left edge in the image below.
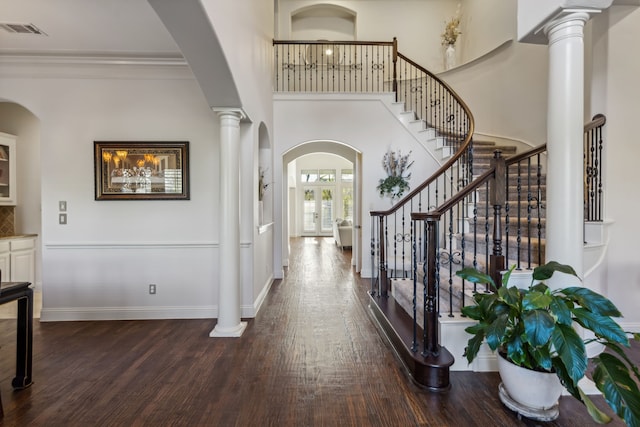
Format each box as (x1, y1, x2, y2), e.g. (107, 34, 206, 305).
(0, 236, 36, 283)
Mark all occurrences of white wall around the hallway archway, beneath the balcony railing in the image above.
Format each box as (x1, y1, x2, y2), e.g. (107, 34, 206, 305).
(274, 95, 438, 277)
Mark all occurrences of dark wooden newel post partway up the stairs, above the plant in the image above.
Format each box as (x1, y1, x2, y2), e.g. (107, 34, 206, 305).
(489, 150, 507, 287)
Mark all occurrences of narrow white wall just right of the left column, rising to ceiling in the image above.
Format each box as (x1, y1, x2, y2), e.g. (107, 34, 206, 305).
(200, 0, 282, 317)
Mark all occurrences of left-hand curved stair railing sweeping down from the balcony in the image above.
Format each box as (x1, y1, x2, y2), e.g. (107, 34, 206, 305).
(369, 46, 475, 310)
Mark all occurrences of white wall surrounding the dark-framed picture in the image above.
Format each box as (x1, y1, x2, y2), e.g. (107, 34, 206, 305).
(0, 64, 225, 320)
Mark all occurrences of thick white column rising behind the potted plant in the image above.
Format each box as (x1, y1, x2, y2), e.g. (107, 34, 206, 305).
(544, 12, 589, 286)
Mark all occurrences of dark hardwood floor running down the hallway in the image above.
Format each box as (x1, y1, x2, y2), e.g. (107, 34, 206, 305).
(0, 238, 640, 427)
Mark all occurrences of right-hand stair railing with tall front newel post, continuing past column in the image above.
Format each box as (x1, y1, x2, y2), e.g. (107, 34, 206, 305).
(410, 114, 606, 382)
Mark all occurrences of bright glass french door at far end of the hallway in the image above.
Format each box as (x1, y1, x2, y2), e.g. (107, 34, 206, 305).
(302, 185, 336, 236)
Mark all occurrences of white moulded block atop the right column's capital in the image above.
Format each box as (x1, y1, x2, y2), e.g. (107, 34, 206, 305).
(518, 0, 613, 44)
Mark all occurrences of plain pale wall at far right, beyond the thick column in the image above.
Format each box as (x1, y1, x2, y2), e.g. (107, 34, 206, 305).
(592, 6, 640, 330)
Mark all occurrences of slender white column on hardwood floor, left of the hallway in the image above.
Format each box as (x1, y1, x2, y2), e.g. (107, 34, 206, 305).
(209, 109, 247, 337)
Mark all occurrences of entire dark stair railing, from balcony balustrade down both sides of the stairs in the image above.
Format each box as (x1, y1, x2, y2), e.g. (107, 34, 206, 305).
(274, 39, 606, 390)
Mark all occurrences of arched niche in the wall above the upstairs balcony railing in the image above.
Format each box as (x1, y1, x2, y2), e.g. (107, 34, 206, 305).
(291, 4, 357, 40)
